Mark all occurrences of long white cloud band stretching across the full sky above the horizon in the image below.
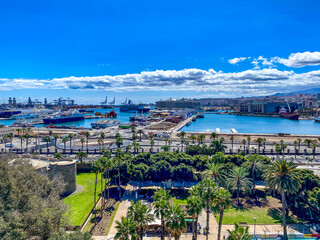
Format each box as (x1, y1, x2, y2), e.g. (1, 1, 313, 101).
(0, 68, 320, 96)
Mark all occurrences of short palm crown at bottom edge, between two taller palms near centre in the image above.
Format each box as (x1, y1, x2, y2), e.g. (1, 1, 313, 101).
(166, 205, 187, 240)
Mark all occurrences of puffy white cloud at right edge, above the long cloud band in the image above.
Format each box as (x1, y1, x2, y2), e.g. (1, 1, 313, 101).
(273, 52, 320, 68)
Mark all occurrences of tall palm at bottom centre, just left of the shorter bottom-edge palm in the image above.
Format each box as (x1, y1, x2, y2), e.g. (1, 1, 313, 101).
(152, 188, 170, 240)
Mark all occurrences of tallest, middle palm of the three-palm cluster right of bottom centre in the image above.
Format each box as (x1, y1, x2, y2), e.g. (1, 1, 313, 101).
(199, 178, 219, 240)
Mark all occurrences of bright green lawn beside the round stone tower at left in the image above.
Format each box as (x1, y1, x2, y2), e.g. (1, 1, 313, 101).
(64, 173, 101, 226)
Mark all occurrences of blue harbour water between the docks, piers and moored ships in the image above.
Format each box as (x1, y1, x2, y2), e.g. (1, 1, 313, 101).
(0, 108, 320, 135)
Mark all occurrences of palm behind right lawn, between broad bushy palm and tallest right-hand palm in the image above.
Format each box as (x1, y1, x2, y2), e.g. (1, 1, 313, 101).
(243, 154, 265, 194)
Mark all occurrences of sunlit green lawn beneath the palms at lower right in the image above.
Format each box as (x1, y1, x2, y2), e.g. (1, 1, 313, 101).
(215, 197, 299, 224)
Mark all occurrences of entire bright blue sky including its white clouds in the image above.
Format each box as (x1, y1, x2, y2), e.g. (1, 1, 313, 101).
(0, 0, 320, 103)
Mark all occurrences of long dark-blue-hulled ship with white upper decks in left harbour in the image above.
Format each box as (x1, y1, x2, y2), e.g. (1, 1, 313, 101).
(43, 109, 84, 124)
